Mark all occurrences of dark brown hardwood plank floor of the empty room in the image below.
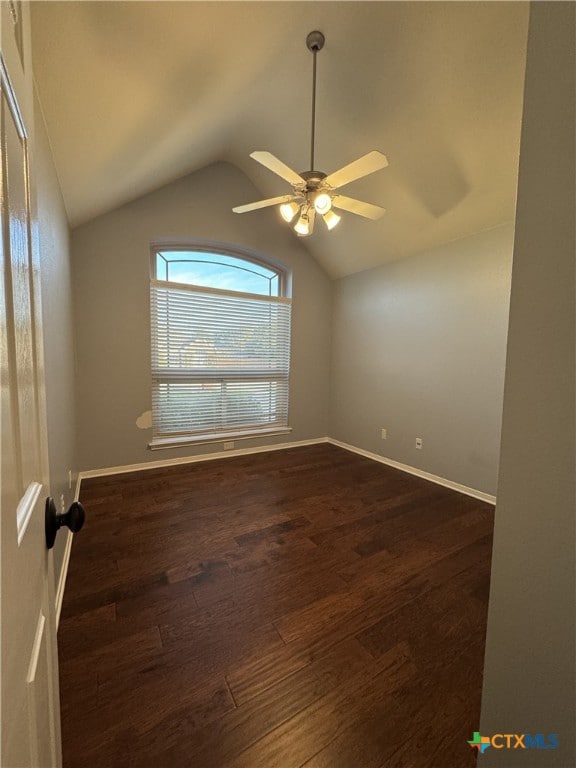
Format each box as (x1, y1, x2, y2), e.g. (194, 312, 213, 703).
(59, 444, 493, 768)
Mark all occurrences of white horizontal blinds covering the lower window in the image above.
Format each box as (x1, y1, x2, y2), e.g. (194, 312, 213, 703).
(151, 280, 291, 438)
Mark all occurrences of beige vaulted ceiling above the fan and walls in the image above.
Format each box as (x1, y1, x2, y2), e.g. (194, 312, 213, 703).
(32, 0, 528, 277)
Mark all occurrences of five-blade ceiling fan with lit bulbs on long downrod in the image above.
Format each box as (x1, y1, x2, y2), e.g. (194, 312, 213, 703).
(232, 30, 388, 237)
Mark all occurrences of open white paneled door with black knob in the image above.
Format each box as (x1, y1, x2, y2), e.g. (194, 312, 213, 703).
(0, 0, 62, 768)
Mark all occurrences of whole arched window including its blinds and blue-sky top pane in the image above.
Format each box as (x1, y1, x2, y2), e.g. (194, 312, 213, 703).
(151, 244, 291, 448)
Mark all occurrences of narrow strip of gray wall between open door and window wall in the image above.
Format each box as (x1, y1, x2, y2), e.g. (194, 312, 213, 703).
(34, 101, 77, 584)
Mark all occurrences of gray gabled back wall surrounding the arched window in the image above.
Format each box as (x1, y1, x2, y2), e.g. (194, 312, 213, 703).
(72, 163, 332, 470)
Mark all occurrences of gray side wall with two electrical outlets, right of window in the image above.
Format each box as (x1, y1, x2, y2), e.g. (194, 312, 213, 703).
(331, 224, 514, 494)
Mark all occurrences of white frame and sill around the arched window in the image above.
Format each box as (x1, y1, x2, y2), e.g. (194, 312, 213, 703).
(148, 240, 292, 450)
